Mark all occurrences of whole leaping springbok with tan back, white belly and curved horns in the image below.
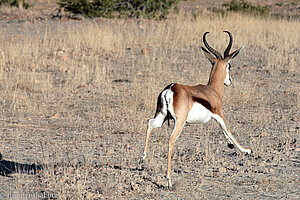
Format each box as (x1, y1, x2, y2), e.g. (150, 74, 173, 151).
(139, 31, 252, 189)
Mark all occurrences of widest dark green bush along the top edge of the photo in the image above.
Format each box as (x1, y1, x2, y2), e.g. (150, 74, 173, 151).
(58, 0, 179, 19)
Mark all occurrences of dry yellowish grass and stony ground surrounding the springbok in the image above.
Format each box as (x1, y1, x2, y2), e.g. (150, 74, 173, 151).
(0, 12, 300, 199)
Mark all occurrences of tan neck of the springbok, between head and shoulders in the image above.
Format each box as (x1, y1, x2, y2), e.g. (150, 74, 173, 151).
(207, 65, 224, 97)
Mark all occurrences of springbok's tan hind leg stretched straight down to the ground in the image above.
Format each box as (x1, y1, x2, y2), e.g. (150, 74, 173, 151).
(167, 119, 185, 190)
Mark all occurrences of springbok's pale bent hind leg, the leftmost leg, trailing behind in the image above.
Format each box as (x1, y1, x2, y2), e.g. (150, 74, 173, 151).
(138, 113, 166, 164)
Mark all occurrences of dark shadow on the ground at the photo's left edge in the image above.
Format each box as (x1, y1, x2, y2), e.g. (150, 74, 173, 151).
(0, 153, 43, 176)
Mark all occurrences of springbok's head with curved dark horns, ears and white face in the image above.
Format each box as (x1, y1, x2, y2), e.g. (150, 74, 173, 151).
(201, 31, 244, 86)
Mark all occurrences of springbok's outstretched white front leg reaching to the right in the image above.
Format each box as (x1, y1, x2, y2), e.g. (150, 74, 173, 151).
(212, 114, 252, 154)
